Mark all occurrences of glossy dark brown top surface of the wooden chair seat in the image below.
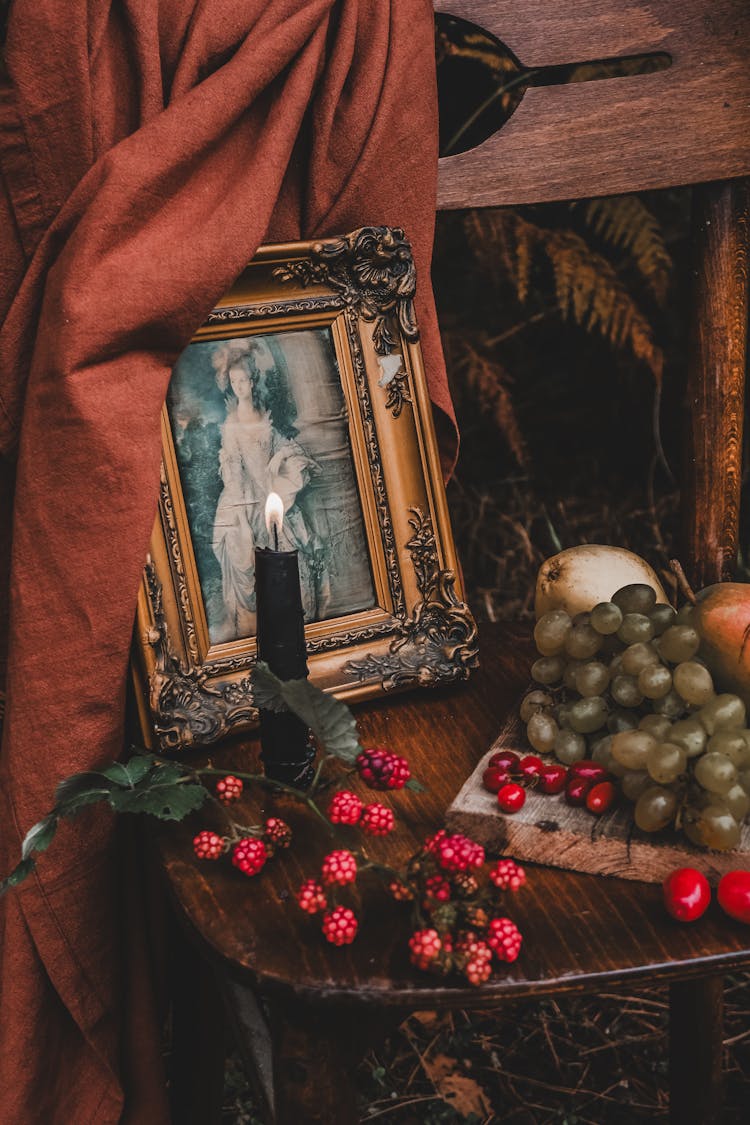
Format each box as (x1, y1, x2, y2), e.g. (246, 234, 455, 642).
(157, 626, 750, 1010)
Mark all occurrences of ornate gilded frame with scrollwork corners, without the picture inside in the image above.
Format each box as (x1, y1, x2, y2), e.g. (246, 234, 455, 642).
(134, 227, 477, 750)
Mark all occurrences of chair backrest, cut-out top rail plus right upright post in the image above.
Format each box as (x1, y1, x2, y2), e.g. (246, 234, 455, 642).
(434, 0, 750, 586)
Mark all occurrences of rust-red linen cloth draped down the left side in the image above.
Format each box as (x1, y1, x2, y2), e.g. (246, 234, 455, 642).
(0, 0, 454, 1125)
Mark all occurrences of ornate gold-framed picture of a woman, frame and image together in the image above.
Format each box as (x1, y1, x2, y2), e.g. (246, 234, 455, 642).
(134, 221, 477, 750)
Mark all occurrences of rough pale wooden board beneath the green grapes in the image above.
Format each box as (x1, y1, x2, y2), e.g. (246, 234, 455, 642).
(446, 717, 750, 883)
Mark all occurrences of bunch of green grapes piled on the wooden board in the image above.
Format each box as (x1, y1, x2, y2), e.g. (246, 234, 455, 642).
(521, 583, 750, 851)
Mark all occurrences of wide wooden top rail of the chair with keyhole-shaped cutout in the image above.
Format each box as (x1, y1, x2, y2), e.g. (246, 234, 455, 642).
(434, 0, 750, 209)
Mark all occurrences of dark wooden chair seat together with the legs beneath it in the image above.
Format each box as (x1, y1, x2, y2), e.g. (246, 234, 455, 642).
(160, 626, 750, 1125)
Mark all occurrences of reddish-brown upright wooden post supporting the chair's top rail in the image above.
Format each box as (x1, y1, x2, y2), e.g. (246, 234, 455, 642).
(681, 180, 750, 590)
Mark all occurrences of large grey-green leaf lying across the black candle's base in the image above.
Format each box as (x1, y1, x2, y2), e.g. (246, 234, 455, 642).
(253, 663, 362, 763)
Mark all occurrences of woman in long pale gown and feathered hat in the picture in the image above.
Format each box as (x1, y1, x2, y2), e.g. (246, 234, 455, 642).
(213, 340, 329, 640)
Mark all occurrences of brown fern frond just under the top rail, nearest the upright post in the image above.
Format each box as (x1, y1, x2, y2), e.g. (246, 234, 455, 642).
(584, 196, 672, 305)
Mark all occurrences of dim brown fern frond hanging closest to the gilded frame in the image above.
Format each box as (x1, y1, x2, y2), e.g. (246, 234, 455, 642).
(443, 332, 527, 468)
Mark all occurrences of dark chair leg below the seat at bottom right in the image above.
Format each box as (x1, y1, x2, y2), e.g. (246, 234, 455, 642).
(669, 977, 724, 1125)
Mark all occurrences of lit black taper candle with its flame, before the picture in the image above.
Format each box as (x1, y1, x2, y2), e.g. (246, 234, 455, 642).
(255, 493, 315, 788)
